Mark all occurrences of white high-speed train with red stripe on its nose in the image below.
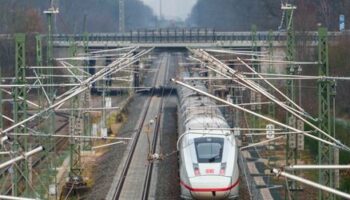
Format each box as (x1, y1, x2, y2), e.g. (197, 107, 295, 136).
(177, 73, 239, 199)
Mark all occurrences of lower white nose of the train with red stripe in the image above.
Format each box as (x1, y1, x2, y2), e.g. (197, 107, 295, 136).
(190, 176, 233, 199)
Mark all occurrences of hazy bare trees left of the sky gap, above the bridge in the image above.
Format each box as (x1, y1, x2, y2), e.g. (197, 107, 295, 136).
(0, 0, 156, 34)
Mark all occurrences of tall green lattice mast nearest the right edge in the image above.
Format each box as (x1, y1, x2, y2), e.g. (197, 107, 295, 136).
(318, 28, 334, 200)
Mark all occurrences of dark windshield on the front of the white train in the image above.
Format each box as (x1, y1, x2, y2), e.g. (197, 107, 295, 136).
(194, 137, 224, 163)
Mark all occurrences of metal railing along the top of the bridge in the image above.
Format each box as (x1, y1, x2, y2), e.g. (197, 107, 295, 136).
(50, 29, 349, 43)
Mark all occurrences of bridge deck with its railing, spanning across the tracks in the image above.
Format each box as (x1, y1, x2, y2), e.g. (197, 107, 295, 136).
(54, 29, 349, 47)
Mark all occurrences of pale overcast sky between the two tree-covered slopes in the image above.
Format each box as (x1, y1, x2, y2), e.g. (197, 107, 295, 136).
(141, 0, 197, 19)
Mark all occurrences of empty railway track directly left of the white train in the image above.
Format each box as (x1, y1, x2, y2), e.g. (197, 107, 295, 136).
(112, 55, 169, 199)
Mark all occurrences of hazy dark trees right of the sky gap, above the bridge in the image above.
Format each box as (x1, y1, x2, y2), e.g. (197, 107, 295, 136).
(187, 0, 350, 31)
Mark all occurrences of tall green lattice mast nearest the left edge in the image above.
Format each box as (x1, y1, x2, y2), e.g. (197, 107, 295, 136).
(12, 33, 30, 196)
